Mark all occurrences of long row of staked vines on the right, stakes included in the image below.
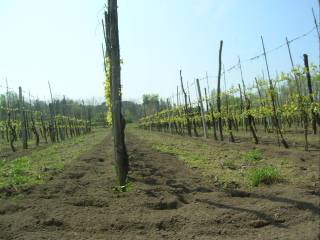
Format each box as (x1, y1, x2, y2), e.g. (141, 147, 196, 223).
(139, 41, 320, 150)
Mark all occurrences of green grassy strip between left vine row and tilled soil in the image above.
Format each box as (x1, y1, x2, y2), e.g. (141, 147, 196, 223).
(0, 129, 106, 193)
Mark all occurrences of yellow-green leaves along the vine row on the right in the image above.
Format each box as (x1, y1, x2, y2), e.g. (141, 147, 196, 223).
(139, 64, 320, 131)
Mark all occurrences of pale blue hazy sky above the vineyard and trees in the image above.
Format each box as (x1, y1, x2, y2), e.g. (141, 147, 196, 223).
(0, 0, 319, 102)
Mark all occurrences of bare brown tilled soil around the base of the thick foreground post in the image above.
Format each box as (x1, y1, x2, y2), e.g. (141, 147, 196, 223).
(0, 133, 320, 240)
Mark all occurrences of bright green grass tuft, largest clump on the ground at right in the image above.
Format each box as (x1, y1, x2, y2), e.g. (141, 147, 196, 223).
(247, 166, 281, 187)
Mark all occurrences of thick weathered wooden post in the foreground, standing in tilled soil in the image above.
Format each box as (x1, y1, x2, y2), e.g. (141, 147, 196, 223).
(107, 0, 129, 187)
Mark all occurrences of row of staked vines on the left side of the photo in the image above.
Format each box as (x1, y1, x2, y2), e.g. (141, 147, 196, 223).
(0, 88, 92, 152)
